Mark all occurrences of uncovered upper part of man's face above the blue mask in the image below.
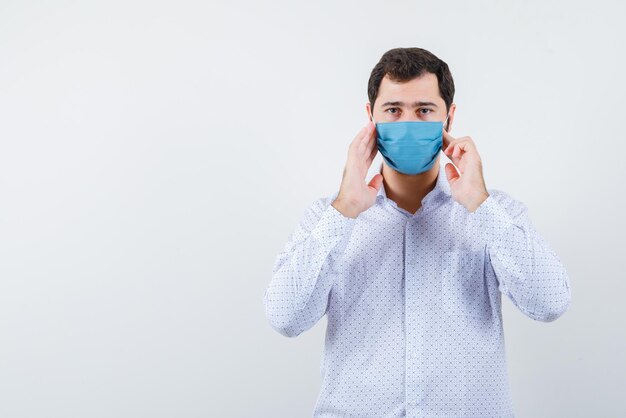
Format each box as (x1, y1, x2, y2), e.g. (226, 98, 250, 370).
(366, 73, 456, 130)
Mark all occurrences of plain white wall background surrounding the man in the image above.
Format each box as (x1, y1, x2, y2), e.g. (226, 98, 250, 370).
(0, 0, 626, 417)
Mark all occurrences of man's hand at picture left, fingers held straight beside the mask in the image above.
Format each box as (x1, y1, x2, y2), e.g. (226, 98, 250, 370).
(332, 121, 383, 218)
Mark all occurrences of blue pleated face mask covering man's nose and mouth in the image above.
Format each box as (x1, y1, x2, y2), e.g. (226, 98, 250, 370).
(372, 112, 448, 175)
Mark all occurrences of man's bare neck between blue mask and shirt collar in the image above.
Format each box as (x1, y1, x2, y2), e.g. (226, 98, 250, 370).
(382, 157, 438, 213)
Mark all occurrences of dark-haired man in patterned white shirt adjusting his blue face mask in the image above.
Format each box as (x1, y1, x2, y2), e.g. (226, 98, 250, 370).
(263, 48, 571, 417)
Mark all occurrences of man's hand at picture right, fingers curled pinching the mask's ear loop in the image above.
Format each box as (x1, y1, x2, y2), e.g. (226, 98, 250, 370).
(443, 129, 489, 212)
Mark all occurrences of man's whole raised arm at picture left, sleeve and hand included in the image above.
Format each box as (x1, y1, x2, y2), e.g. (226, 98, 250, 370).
(263, 121, 383, 337)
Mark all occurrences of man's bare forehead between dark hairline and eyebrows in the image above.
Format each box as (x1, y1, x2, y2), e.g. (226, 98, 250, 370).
(376, 73, 444, 104)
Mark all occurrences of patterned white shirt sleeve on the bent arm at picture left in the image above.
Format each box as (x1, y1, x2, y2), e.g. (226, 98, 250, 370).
(263, 198, 356, 337)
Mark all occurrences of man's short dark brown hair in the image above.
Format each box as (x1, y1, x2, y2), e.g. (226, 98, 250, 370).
(367, 48, 454, 111)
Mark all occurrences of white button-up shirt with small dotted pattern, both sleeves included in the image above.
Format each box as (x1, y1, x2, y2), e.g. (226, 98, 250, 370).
(263, 158, 571, 418)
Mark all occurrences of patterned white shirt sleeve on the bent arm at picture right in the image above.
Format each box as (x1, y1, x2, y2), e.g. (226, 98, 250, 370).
(471, 190, 571, 322)
